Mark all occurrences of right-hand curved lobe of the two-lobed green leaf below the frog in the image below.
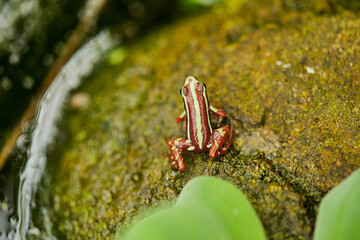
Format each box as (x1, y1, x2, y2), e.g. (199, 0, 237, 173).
(176, 177, 266, 240)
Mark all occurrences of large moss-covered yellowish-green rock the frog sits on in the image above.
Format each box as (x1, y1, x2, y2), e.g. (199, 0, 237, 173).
(44, 1, 360, 239)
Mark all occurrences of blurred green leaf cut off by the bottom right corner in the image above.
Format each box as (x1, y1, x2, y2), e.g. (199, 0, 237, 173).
(314, 168, 360, 240)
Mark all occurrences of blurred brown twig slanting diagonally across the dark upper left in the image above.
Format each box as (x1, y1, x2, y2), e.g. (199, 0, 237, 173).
(0, 0, 107, 170)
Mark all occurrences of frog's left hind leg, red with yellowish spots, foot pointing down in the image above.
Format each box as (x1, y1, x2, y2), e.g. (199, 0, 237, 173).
(168, 138, 192, 171)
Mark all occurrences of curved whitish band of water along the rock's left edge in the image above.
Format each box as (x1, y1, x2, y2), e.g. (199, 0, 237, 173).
(0, 31, 116, 240)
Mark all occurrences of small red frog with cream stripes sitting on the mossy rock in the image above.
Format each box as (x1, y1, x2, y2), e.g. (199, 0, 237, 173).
(167, 76, 233, 171)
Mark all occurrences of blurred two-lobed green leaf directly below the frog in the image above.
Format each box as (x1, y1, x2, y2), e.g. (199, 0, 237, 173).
(119, 177, 266, 240)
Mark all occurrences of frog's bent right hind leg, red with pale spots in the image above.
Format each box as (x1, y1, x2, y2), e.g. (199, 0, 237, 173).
(208, 124, 233, 158)
